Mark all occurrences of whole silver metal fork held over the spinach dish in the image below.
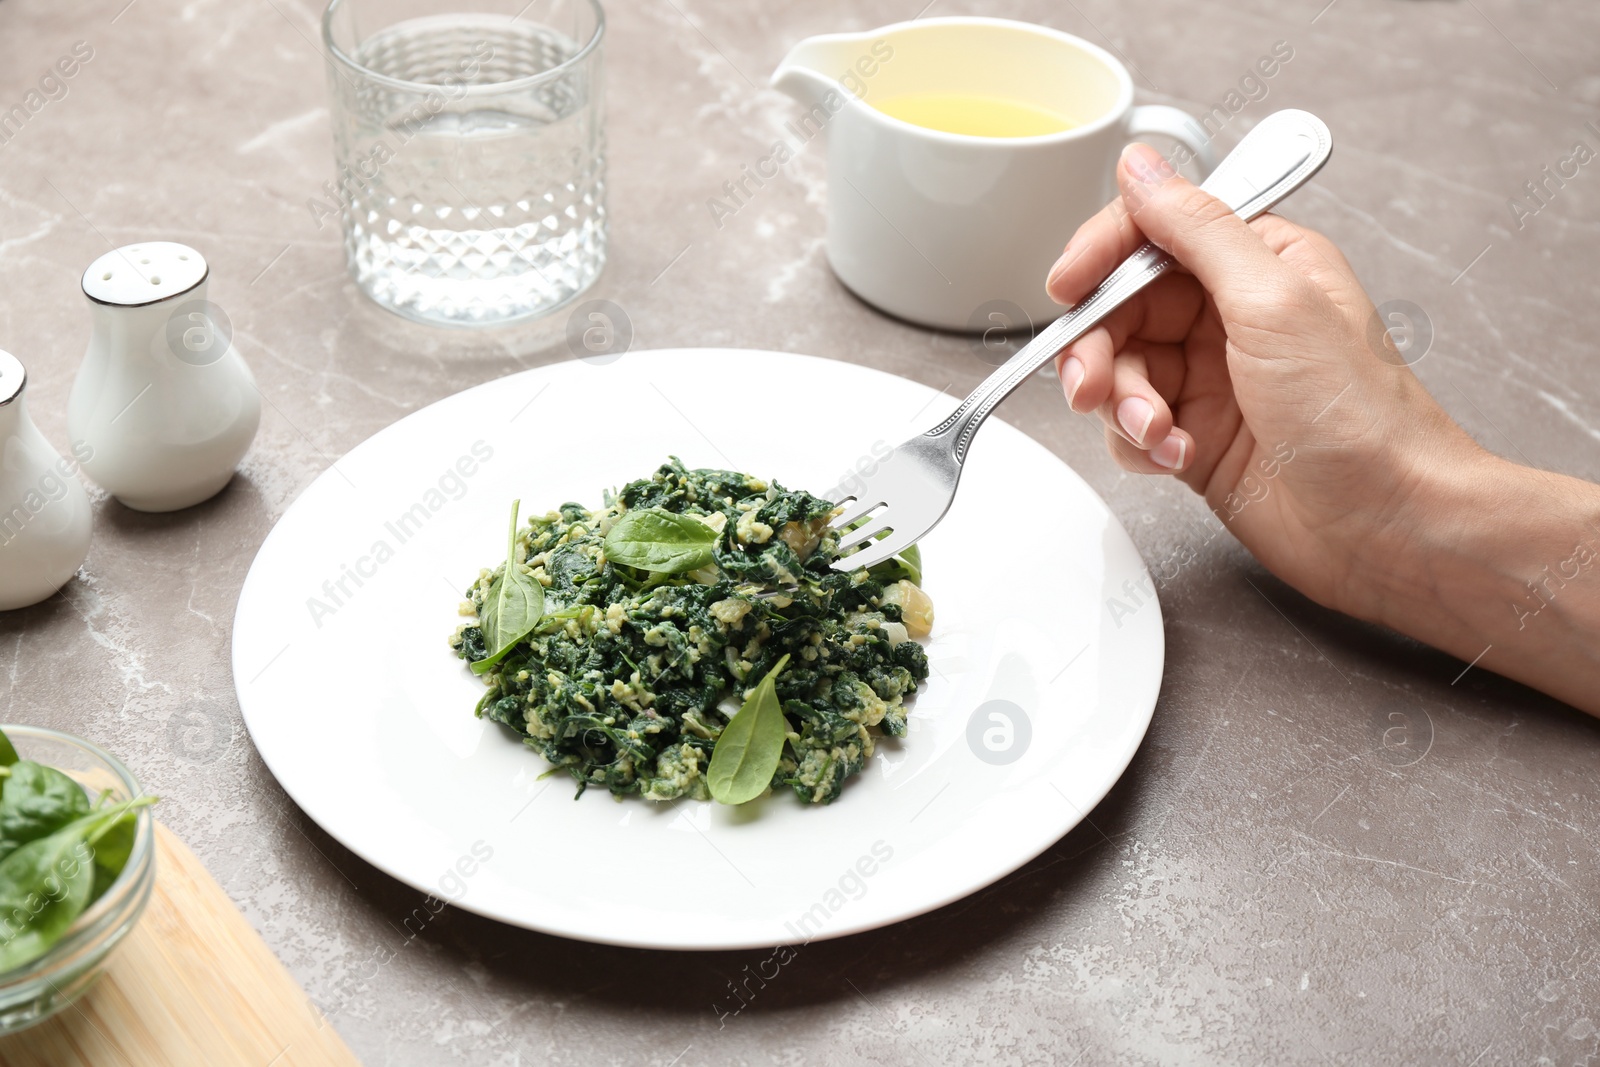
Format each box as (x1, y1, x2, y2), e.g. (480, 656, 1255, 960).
(829, 109, 1333, 571)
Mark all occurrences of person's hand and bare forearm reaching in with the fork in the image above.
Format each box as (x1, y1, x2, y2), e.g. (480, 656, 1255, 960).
(1046, 146, 1600, 715)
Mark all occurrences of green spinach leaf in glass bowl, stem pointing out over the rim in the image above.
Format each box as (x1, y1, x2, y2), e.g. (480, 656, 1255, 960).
(0, 797, 155, 971)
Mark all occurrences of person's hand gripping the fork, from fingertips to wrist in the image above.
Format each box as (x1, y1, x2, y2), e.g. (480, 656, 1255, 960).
(1048, 144, 1491, 617)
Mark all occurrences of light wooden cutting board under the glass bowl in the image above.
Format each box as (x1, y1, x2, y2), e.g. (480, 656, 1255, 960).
(0, 822, 360, 1067)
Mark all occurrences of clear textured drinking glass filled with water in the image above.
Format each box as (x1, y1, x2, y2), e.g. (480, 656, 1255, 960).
(323, 0, 606, 326)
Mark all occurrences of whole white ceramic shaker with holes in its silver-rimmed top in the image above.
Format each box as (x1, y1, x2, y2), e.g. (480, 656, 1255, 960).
(67, 242, 261, 512)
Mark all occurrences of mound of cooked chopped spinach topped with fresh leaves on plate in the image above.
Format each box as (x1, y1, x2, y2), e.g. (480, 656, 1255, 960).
(451, 459, 933, 803)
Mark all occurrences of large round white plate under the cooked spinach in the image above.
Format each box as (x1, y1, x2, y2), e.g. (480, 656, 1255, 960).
(234, 349, 1163, 949)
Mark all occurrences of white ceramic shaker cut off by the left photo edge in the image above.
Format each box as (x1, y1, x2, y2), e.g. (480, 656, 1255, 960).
(0, 352, 90, 611)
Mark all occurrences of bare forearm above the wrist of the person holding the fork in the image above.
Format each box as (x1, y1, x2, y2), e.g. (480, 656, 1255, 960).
(1371, 453, 1600, 715)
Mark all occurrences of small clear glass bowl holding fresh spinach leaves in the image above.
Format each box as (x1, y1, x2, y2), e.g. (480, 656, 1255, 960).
(0, 725, 155, 1033)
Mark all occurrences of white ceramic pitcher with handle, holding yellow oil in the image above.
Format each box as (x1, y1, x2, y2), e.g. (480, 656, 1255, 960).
(773, 18, 1214, 330)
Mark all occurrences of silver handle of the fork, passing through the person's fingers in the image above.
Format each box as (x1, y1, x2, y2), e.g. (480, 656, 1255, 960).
(923, 109, 1333, 464)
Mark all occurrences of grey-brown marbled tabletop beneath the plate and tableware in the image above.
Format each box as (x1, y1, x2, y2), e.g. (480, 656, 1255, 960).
(0, 0, 1600, 1067)
